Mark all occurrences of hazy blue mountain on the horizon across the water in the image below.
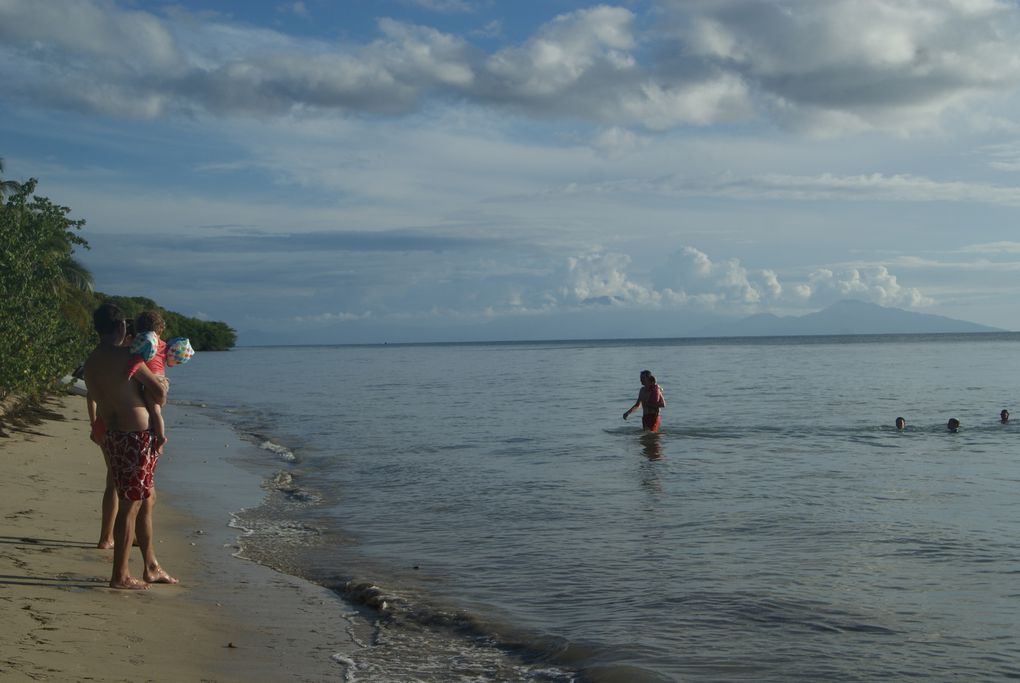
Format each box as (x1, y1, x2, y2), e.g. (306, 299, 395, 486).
(698, 300, 1006, 336)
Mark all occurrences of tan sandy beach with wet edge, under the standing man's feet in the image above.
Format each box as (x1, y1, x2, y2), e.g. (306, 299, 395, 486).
(0, 397, 367, 681)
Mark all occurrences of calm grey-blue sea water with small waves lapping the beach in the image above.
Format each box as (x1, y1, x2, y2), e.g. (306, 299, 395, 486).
(163, 333, 1020, 681)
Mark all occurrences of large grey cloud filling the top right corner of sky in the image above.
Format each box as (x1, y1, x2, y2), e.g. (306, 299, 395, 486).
(660, 0, 1020, 134)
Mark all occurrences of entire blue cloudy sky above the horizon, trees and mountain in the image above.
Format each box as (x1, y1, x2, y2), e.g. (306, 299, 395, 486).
(0, 0, 1020, 345)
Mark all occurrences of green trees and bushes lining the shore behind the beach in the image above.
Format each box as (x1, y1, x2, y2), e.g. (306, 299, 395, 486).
(0, 159, 237, 402)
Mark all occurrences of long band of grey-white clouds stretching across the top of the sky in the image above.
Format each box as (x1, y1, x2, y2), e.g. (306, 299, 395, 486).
(7, 0, 1020, 133)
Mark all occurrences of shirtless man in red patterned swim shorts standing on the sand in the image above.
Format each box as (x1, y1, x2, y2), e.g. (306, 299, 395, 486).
(85, 304, 177, 589)
